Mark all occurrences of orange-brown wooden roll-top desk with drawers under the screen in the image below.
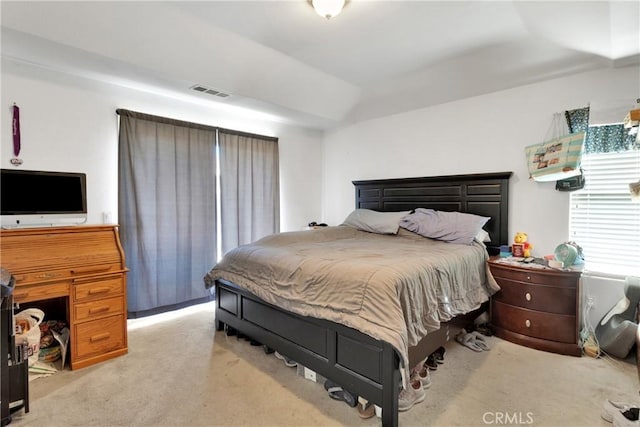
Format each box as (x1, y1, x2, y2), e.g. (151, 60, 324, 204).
(0, 225, 128, 369)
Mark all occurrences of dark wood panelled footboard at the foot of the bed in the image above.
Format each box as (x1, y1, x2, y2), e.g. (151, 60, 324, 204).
(216, 280, 400, 426)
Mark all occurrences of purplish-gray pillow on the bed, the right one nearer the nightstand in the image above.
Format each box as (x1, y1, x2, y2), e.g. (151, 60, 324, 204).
(400, 208, 491, 245)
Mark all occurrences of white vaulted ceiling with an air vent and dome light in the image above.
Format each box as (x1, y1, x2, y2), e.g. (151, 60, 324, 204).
(1, 0, 640, 129)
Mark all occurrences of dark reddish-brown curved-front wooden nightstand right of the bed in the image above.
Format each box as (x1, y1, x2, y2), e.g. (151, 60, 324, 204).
(489, 260, 582, 356)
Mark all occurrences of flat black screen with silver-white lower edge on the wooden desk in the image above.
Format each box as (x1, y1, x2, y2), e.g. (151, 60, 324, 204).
(0, 169, 87, 228)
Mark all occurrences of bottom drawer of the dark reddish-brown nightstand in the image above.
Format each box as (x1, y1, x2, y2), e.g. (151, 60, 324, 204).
(491, 300, 577, 343)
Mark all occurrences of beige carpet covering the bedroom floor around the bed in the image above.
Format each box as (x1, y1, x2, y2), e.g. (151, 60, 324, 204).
(11, 304, 640, 426)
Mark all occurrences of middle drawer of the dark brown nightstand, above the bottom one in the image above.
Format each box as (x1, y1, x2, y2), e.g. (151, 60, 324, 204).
(493, 278, 577, 315)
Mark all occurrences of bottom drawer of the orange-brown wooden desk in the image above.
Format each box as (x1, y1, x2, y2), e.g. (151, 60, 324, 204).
(75, 315, 126, 359)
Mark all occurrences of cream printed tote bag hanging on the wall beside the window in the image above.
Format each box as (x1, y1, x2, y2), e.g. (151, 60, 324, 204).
(525, 132, 585, 182)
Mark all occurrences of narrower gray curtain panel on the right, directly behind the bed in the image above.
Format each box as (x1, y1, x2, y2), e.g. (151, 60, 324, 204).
(218, 129, 280, 254)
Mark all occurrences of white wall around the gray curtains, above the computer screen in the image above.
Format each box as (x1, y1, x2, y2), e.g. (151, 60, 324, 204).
(0, 60, 322, 231)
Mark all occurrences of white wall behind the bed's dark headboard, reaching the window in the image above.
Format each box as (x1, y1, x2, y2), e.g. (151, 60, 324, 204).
(323, 66, 640, 319)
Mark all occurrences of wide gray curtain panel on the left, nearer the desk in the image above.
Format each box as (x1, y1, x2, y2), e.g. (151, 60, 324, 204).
(117, 110, 216, 317)
